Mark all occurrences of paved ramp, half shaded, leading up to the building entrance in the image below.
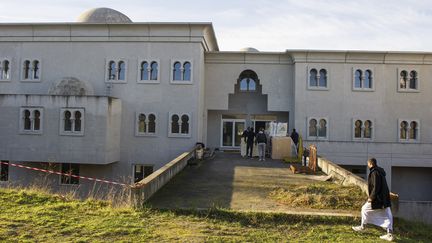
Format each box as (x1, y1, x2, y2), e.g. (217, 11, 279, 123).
(149, 152, 358, 216)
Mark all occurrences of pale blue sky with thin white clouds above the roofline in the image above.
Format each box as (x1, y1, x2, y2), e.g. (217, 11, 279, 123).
(0, 0, 432, 52)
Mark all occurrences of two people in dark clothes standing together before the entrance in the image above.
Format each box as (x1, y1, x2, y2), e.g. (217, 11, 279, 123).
(242, 127, 267, 161)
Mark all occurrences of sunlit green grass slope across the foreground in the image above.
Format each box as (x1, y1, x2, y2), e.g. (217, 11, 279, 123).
(0, 189, 432, 242)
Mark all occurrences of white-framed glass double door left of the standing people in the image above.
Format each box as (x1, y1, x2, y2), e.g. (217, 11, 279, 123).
(221, 119, 246, 149)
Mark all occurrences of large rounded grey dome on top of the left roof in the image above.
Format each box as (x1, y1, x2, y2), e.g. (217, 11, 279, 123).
(77, 8, 132, 24)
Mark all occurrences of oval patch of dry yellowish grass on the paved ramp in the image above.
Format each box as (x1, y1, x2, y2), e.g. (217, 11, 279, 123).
(269, 182, 366, 210)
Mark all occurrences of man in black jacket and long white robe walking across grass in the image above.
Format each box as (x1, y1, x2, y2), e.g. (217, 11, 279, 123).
(352, 158, 393, 241)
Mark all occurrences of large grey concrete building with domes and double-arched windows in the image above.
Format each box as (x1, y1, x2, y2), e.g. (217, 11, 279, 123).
(0, 8, 432, 204)
